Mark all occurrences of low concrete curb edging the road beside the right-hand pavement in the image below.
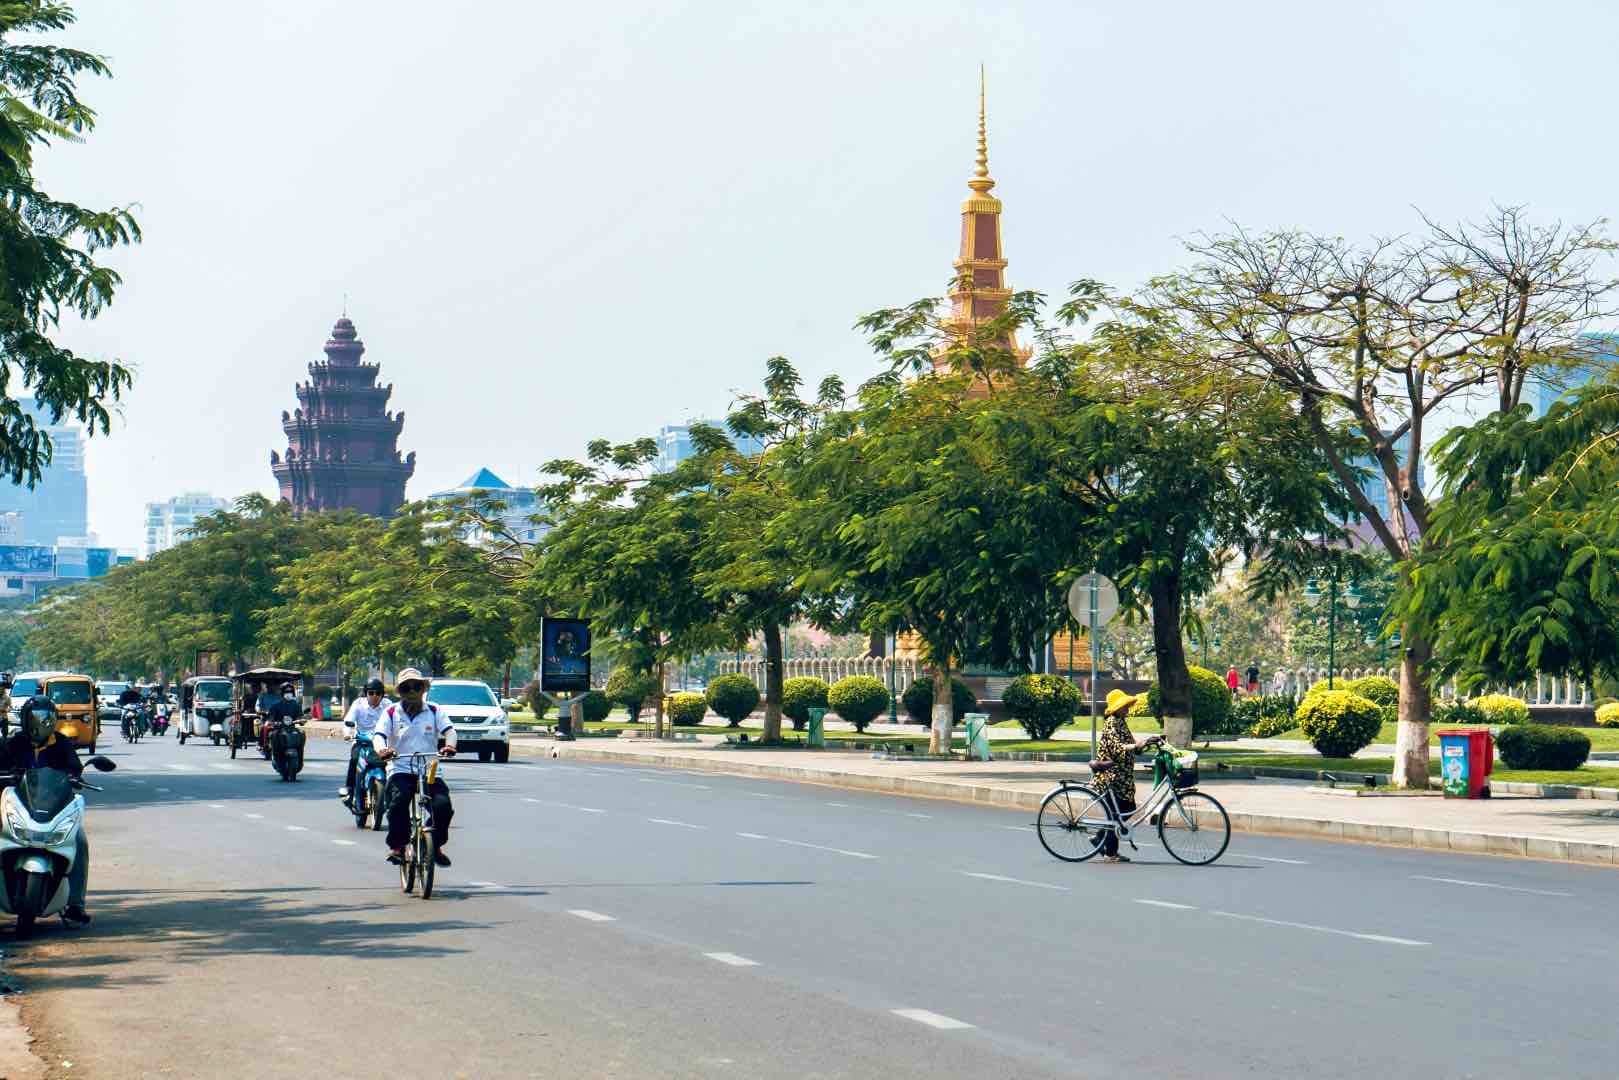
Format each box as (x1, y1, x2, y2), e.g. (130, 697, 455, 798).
(512, 743, 1619, 866)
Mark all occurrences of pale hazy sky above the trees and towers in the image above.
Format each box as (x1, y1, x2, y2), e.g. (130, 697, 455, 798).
(22, 0, 1619, 547)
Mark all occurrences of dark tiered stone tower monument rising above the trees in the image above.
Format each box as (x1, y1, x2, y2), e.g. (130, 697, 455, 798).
(270, 316, 416, 518)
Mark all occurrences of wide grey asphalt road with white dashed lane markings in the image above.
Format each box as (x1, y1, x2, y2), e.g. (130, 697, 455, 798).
(0, 738, 1619, 1080)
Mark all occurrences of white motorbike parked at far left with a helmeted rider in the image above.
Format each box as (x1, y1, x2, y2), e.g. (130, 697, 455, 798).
(0, 756, 117, 938)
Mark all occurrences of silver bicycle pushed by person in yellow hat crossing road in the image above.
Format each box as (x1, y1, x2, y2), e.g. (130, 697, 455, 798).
(1035, 743, 1230, 866)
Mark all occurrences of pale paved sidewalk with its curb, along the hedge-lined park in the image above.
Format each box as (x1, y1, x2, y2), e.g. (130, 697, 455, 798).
(512, 735, 1619, 866)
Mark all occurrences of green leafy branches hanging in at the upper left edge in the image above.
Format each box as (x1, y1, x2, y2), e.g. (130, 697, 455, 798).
(0, 0, 141, 486)
